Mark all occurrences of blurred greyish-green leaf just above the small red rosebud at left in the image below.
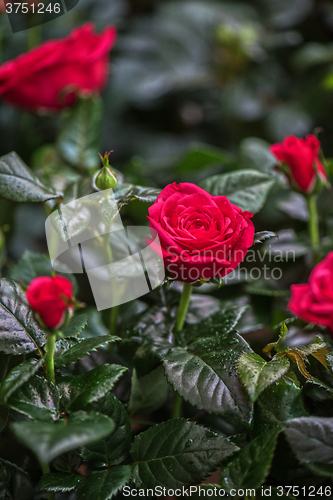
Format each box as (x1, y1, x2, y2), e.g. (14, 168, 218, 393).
(11, 250, 75, 285)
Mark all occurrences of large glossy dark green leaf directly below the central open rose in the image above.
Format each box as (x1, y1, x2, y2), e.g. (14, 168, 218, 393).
(164, 332, 252, 423)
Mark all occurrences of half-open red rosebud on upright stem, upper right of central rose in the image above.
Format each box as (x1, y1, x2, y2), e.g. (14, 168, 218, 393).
(269, 135, 327, 193)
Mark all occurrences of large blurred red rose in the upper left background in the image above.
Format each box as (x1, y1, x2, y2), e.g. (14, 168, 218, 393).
(0, 24, 116, 111)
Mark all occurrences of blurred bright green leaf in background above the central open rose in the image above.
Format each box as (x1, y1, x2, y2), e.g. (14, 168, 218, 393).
(175, 144, 233, 174)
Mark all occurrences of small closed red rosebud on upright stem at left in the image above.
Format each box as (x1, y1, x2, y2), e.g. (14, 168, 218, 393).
(26, 276, 74, 330)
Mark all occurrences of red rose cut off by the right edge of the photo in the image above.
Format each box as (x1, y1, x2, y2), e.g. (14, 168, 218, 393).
(288, 252, 333, 330)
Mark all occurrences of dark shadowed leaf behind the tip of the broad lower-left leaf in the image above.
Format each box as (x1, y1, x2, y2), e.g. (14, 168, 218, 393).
(81, 392, 132, 467)
